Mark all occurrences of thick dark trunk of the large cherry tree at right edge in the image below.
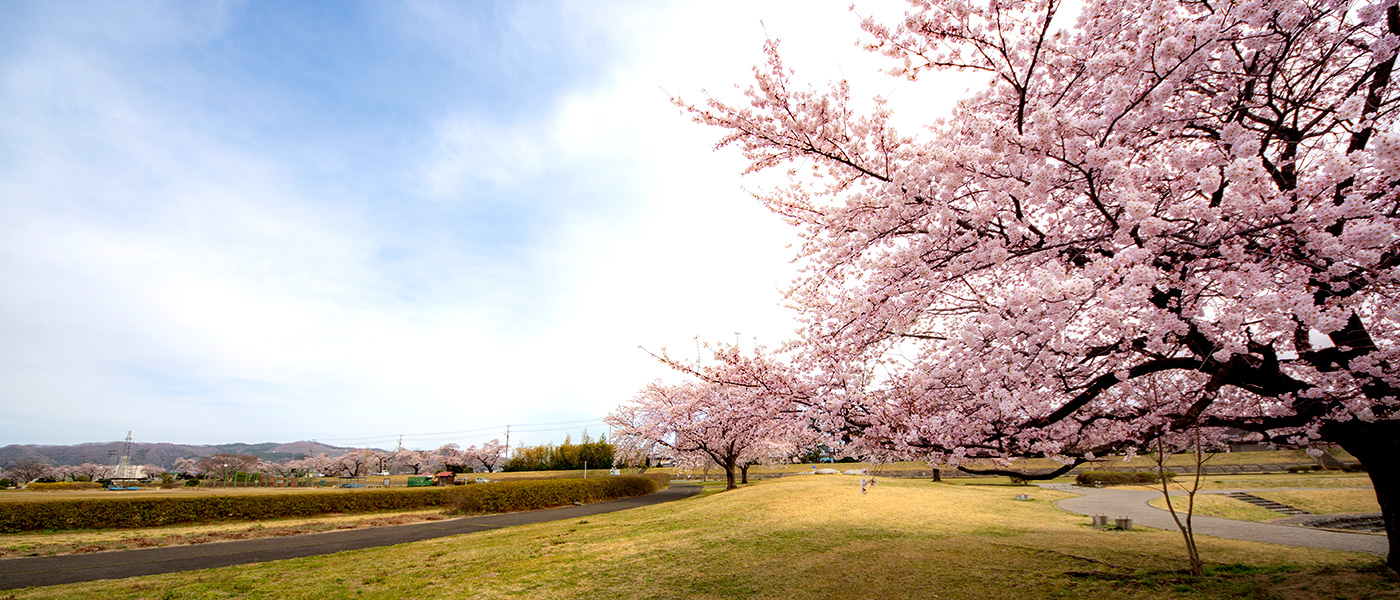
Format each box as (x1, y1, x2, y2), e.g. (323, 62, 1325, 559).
(1320, 421, 1400, 572)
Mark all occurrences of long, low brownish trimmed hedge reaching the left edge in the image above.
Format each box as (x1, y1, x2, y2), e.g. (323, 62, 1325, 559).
(0, 488, 445, 533)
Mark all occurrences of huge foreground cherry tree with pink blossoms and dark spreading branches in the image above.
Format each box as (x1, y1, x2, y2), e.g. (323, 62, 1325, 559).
(689, 0, 1400, 568)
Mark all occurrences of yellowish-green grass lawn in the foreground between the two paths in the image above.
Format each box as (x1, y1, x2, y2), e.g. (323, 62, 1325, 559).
(13, 476, 1400, 600)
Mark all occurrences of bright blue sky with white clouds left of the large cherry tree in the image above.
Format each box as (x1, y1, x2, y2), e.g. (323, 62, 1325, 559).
(0, 1, 963, 448)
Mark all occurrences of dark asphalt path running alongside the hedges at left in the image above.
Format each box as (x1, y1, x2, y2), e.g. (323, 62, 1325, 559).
(0, 484, 700, 590)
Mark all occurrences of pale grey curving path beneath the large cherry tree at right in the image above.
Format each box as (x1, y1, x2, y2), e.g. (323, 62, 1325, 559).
(1040, 484, 1390, 555)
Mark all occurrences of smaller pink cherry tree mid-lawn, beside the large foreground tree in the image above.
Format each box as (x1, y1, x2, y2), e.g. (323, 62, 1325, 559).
(603, 382, 801, 490)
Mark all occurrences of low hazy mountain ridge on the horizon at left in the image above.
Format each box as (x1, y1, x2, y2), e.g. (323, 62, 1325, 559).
(0, 442, 372, 469)
